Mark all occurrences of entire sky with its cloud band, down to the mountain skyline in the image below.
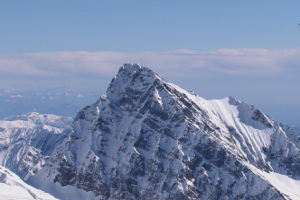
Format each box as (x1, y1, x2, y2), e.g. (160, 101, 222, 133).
(0, 0, 300, 123)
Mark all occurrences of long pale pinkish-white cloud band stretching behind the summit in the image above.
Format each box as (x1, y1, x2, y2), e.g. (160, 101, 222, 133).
(0, 49, 300, 88)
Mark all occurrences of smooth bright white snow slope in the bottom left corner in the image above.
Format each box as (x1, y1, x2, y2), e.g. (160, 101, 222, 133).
(0, 166, 57, 200)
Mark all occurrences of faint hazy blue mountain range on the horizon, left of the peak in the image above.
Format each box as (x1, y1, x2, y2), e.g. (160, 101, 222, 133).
(0, 87, 99, 117)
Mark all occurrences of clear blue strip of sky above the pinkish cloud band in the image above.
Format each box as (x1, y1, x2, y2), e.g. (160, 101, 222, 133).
(0, 0, 300, 54)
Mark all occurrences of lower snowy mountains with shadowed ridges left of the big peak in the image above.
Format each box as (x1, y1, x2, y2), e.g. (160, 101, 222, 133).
(0, 113, 73, 180)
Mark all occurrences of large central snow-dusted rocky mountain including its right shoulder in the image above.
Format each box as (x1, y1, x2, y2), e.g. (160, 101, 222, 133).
(31, 64, 300, 200)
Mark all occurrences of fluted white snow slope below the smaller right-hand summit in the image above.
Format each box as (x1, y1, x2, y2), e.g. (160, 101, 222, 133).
(205, 97, 274, 162)
